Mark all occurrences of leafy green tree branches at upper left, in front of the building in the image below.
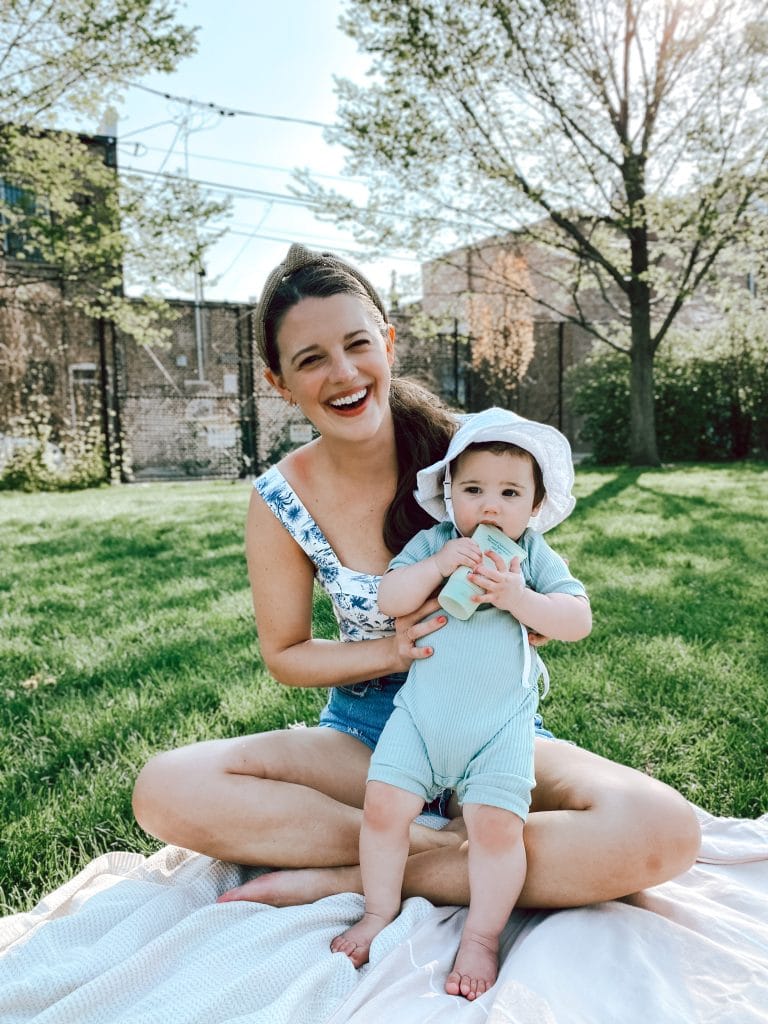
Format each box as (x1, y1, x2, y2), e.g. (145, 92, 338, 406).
(0, 0, 226, 340)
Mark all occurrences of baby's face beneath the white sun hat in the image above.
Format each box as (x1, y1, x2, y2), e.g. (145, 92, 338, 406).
(451, 452, 536, 541)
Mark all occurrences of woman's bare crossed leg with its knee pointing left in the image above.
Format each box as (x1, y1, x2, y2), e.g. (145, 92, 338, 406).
(133, 728, 458, 876)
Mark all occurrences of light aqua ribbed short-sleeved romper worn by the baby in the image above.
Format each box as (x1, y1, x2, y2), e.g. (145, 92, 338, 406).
(369, 522, 586, 819)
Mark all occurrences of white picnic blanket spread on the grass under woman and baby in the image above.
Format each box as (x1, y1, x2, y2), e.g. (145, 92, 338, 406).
(0, 811, 768, 1024)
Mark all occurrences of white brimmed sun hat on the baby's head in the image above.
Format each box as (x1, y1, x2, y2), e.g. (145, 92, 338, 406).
(414, 407, 575, 534)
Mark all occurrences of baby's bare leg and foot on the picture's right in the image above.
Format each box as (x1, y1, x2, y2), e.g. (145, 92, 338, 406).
(445, 804, 525, 999)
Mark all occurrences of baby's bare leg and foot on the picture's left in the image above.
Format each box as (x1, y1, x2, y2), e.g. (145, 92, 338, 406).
(331, 781, 424, 967)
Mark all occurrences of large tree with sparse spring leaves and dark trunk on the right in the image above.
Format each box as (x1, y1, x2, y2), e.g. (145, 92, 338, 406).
(300, 0, 768, 464)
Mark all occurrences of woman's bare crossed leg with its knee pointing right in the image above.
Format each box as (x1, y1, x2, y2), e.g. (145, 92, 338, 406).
(233, 739, 700, 908)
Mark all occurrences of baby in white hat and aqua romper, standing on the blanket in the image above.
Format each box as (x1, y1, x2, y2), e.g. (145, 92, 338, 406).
(331, 409, 592, 999)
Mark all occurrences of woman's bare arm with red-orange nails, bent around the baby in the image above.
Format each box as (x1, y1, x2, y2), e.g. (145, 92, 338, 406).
(246, 490, 439, 686)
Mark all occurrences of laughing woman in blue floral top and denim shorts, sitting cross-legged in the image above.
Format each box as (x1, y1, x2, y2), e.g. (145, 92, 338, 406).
(134, 246, 699, 907)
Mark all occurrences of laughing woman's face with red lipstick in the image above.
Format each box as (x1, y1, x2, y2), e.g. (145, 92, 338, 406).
(266, 293, 394, 437)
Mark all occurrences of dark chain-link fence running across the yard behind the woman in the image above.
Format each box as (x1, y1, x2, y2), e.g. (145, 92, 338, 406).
(0, 294, 591, 480)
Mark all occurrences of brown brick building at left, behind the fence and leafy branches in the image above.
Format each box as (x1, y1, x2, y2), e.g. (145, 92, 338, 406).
(0, 125, 307, 479)
